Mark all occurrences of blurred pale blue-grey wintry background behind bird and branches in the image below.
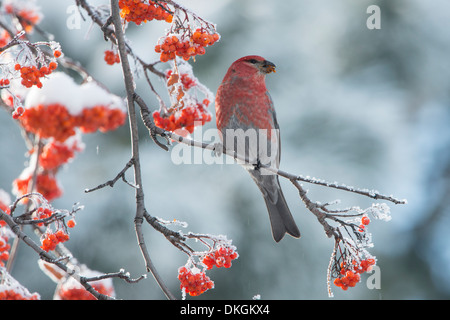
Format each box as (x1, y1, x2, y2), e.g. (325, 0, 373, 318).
(0, 0, 450, 299)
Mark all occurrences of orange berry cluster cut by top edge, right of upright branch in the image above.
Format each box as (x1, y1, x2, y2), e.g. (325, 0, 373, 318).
(119, 0, 173, 25)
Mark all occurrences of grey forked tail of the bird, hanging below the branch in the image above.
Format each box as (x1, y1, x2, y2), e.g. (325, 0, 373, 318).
(252, 174, 300, 242)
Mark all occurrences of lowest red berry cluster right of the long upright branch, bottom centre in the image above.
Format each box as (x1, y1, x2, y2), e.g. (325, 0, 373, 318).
(178, 267, 214, 297)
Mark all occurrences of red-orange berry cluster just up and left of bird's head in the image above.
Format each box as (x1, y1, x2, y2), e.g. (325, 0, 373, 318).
(155, 29, 220, 62)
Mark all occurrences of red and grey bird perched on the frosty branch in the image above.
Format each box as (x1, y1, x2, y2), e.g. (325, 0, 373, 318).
(215, 56, 300, 242)
